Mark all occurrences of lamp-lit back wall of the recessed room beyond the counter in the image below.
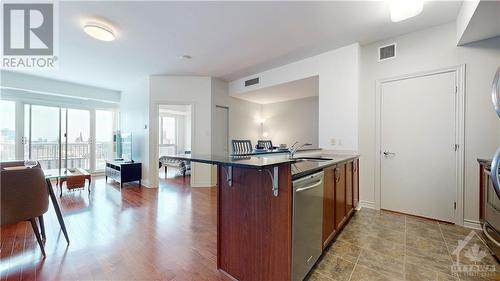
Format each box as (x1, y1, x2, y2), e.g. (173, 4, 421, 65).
(262, 97, 319, 147)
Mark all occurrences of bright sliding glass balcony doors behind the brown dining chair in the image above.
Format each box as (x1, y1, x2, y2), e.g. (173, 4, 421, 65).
(13, 100, 115, 172)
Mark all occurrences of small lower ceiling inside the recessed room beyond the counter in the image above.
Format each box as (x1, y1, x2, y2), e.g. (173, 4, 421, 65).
(234, 76, 319, 104)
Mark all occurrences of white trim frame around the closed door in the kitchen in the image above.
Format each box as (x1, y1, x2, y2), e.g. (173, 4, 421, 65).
(375, 64, 465, 225)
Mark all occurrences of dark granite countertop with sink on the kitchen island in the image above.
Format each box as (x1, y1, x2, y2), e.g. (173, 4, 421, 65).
(163, 151, 359, 175)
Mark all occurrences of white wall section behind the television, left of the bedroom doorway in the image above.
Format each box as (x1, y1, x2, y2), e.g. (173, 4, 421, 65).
(120, 77, 149, 187)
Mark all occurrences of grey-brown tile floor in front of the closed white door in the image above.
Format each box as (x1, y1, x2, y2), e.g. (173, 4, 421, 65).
(309, 209, 500, 281)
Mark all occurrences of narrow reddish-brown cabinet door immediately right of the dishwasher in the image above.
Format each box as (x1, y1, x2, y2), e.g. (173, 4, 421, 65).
(323, 167, 335, 246)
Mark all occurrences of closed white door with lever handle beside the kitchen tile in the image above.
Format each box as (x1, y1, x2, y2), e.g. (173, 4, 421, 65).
(380, 71, 457, 222)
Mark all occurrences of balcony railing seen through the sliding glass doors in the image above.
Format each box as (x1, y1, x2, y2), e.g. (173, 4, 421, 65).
(0, 141, 113, 170)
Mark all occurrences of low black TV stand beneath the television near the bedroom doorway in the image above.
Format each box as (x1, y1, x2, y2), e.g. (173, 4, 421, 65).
(106, 161, 142, 188)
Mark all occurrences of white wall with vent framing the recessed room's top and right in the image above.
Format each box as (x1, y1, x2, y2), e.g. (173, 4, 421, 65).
(229, 43, 359, 150)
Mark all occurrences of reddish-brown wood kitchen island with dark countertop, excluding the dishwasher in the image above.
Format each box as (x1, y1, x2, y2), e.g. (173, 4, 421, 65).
(167, 151, 359, 280)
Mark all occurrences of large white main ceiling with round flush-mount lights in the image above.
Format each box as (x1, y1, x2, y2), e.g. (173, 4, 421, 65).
(6, 1, 461, 90)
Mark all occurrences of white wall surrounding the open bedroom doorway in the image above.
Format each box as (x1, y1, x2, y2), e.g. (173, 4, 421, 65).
(149, 76, 212, 187)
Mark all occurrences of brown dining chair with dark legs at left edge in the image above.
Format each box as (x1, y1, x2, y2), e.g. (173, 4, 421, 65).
(0, 161, 49, 257)
